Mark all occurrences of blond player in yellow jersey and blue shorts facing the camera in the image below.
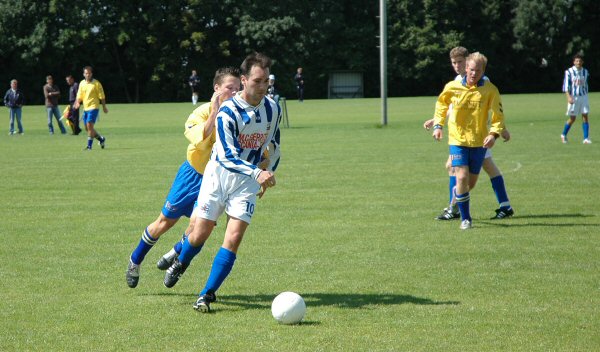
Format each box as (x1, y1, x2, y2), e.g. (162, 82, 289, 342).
(433, 53, 505, 229)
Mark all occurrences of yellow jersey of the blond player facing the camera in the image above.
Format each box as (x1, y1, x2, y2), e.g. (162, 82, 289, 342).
(434, 78, 505, 147)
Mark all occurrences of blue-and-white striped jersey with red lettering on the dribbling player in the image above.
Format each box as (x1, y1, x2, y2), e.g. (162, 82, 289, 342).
(211, 92, 281, 179)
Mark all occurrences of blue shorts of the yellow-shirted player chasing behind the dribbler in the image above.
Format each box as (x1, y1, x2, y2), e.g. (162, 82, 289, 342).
(162, 160, 202, 219)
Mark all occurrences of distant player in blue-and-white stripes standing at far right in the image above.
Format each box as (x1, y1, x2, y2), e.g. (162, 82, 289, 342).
(560, 54, 592, 144)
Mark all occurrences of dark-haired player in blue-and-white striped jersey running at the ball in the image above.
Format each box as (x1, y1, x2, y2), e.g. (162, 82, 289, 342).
(164, 53, 281, 312)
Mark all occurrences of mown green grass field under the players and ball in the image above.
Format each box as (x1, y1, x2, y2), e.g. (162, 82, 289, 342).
(0, 93, 600, 351)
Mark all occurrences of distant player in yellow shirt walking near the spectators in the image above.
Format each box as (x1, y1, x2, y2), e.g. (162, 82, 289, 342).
(73, 66, 108, 150)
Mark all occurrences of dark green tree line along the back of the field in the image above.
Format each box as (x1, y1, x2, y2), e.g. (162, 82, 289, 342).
(0, 0, 600, 104)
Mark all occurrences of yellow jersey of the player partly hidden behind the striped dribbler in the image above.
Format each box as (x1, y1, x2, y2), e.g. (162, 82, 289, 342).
(184, 103, 217, 174)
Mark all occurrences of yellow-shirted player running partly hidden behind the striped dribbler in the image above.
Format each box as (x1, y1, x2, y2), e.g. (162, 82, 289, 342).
(125, 67, 240, 288)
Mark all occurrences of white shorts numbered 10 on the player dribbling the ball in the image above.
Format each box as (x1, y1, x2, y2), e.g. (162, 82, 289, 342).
(194, 160, 260, 224)
